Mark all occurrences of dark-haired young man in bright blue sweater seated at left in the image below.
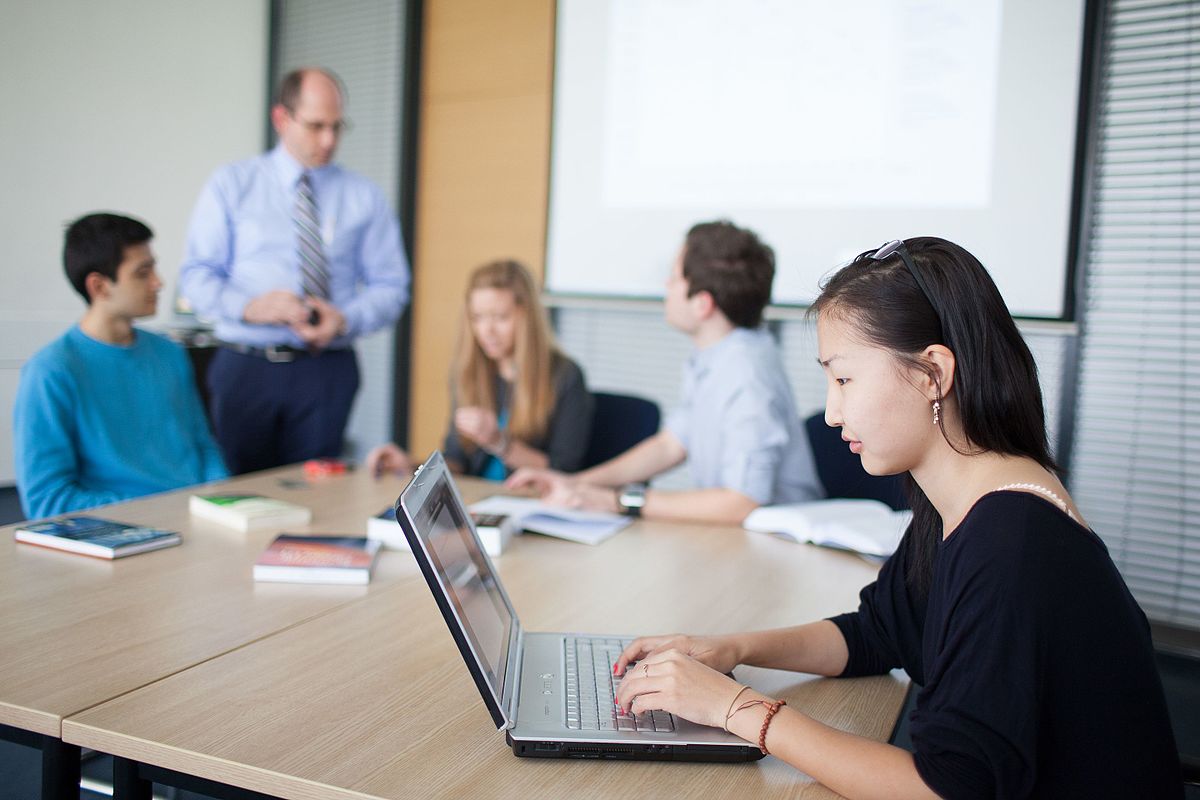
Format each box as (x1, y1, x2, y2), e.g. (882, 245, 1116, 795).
(13, 213, 228, 519)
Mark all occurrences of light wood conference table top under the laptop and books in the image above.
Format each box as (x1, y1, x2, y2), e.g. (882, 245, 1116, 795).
(0, 468, 906, 800)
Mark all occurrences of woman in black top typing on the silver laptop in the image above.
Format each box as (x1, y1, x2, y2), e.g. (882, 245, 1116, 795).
(614, 237, 1182, 798)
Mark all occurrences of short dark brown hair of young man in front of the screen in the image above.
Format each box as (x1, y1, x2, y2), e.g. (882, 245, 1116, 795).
(683, 219, 775, 327)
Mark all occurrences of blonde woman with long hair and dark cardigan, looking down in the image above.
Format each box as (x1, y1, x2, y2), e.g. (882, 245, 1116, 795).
(367, 260, 593, 480)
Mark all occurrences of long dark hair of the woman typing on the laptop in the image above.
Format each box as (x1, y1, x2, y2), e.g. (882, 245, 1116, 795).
(809, 236, 1060, 594)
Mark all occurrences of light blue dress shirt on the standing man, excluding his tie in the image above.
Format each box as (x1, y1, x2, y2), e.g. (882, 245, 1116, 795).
(179, 145, 409, 348)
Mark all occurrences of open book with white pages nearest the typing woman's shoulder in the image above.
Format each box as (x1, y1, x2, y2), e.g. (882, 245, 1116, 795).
(742, 500, 912, 558)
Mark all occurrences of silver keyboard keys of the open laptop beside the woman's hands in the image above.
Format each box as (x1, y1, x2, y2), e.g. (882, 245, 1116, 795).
(563, 637, 674, 732)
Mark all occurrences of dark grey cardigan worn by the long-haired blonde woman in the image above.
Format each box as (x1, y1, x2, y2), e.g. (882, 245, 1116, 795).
(442, 355, 595, 475)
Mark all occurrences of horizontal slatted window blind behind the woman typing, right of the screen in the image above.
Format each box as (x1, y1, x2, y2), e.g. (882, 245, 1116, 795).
(1070, 0, 1200, 628)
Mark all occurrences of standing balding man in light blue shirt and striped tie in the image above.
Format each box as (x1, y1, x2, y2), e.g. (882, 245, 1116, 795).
(180, 67, 408, 474)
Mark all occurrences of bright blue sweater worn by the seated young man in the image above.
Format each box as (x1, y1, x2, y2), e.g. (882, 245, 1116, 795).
(13, 325, 228, 519)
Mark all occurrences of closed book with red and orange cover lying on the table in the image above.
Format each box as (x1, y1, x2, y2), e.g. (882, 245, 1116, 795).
(254, 534, 382, 584)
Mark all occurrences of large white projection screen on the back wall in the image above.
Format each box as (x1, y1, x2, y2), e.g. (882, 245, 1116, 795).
(546, 0, 1084, 318)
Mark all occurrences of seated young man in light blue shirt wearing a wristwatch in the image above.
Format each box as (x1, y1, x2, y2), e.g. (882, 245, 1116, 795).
(509, 222, 824, 524)
